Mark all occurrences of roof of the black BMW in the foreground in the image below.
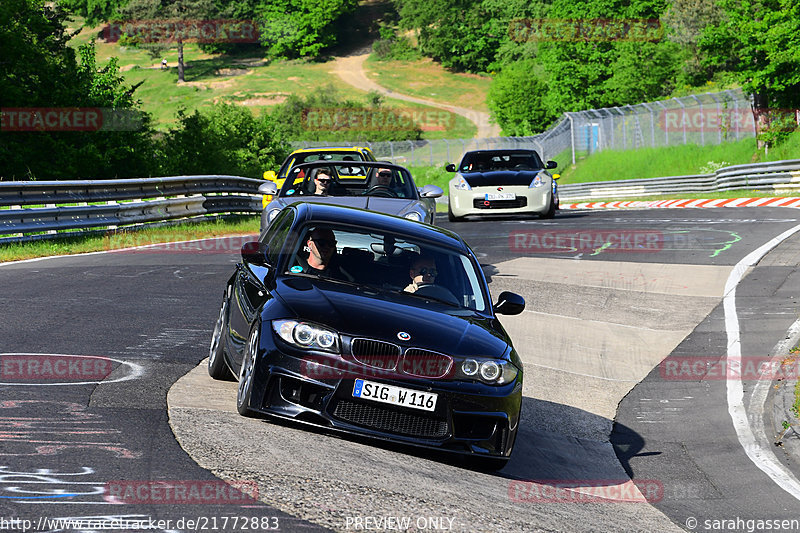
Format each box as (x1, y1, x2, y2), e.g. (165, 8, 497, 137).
(291, 202, 466, 249)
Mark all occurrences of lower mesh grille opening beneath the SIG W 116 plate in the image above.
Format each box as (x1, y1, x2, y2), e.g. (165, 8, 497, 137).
(333, 400, 448, 439)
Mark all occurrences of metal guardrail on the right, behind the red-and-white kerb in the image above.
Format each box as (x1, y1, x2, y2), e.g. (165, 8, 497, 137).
(558, 159, 800, 201)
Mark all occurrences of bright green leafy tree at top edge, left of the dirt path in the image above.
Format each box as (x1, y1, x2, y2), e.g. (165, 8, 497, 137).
(256, 0, 358, 58)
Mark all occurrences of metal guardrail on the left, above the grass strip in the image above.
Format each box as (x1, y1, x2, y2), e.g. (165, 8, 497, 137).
(0, 176, 263, 242)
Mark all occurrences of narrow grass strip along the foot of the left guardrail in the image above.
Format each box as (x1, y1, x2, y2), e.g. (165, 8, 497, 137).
(0, 216, 260, 262)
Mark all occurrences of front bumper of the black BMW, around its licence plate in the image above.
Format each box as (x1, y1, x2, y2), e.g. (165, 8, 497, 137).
(241, 323, 522, 458)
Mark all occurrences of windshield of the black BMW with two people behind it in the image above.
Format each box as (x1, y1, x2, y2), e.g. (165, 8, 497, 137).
(283, 226, 487, 311)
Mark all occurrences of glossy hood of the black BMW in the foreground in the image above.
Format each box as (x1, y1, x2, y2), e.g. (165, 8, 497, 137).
(272, 277, 508, 358)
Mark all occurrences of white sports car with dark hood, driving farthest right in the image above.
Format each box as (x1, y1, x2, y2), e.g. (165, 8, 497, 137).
(446, 150, 558, 222)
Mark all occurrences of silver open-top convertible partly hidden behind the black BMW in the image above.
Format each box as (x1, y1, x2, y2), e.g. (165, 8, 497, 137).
(258, 161, 442, 233)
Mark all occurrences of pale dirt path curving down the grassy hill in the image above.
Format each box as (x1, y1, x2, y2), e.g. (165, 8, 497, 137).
(333, 50, 500, 139)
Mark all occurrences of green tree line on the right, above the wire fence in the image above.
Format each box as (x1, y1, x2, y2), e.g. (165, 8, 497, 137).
(395, 0, 800, 140)
